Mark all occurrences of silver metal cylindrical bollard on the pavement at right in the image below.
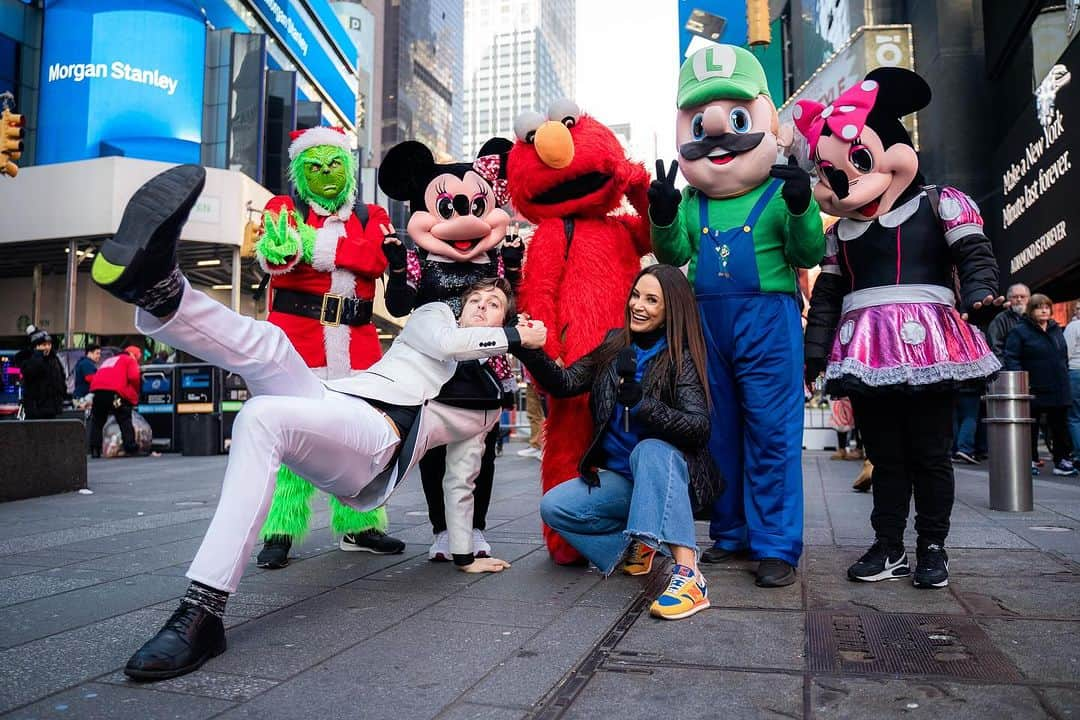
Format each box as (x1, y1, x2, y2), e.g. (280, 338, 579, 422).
(983, 370, 1035, 513)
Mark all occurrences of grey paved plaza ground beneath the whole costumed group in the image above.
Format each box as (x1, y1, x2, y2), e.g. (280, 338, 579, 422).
(0, 445, 1080, 720)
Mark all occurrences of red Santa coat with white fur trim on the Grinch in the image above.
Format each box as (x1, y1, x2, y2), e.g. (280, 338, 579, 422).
(258, 195, 390, 379)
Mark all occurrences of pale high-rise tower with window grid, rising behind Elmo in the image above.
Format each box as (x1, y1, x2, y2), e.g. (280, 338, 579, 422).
(462, 0, 577, 157)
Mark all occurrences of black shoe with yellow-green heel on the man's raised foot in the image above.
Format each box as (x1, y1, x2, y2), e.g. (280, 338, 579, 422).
(91, 165, 206, 316)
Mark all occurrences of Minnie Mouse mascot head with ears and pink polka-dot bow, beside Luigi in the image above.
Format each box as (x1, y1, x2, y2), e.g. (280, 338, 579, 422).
(794, 68, 930, 221)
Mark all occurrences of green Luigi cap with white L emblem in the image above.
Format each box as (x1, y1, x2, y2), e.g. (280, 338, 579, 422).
(678, 44, 771, 110)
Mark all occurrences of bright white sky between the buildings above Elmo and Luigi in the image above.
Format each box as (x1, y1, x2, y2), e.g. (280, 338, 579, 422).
(573, 0, 679, 166)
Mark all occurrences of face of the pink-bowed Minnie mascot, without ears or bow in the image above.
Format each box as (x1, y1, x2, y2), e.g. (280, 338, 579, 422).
(813, 126, 919, 220)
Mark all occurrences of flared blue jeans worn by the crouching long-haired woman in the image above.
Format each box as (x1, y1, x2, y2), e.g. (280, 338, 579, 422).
(540, 439, 697, 575)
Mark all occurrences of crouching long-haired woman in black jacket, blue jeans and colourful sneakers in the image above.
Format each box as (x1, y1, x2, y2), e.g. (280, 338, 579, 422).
(515, 264, 721, 620)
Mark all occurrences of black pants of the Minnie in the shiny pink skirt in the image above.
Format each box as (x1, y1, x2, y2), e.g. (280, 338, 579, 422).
(851, 391, 955, 547)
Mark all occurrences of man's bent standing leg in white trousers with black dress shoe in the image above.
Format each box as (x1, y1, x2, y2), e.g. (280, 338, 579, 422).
(124, 392, 399, 680)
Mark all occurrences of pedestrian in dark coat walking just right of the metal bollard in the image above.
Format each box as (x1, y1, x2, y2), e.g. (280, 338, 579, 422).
(1005, 294, 1080, 477)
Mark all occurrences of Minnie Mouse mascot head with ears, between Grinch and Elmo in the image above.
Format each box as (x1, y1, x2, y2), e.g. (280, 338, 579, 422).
(379, 138, 511, 262)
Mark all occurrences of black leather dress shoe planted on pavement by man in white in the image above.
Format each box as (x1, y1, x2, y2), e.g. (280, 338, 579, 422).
(124, 602, 225, 681)
